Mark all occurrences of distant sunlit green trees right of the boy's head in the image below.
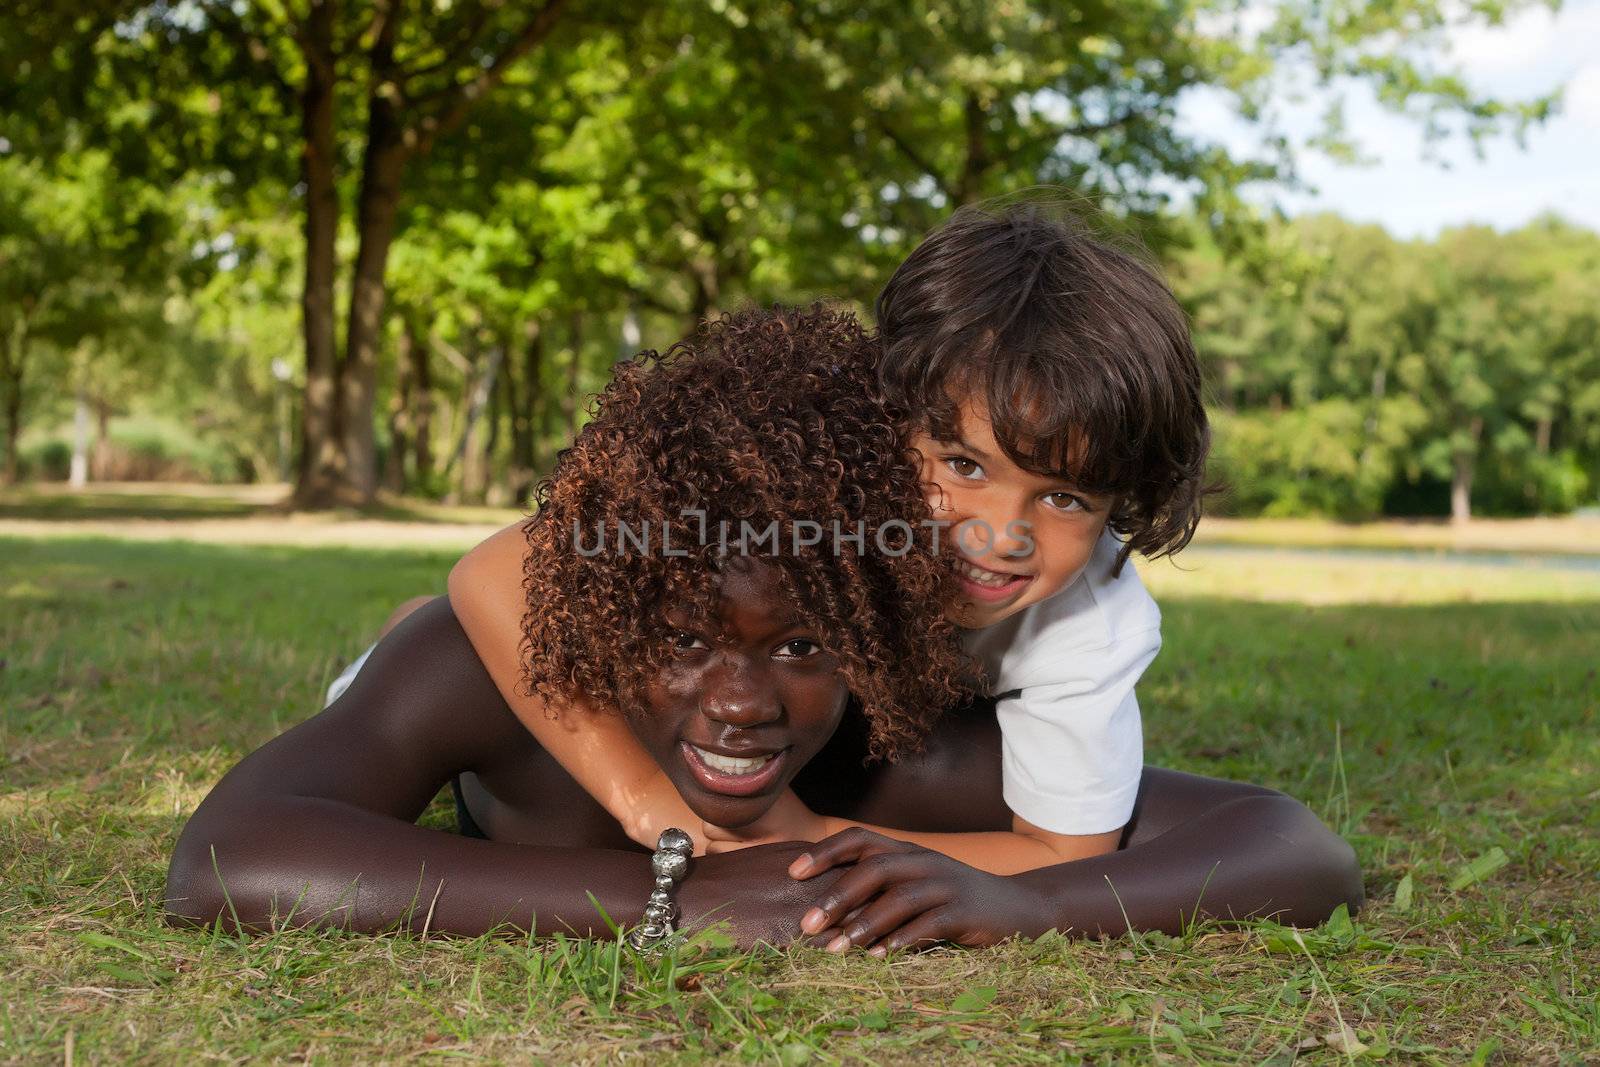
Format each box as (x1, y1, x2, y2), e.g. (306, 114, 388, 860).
(1173, 218, 1600, 520)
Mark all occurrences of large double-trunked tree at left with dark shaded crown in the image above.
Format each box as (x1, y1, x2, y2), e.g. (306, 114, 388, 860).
(7, 0, 582, 506)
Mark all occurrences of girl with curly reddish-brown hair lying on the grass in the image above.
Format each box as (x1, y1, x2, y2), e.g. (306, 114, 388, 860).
(166, 303, 1360, 953)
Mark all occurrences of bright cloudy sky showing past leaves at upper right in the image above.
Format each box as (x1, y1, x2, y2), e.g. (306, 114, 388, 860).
(1181, 0, 1600, 237)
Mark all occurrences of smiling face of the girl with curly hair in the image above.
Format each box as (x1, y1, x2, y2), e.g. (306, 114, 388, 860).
(627, 558, 850, 827)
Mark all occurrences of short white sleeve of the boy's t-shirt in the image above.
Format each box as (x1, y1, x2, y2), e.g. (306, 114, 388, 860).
(995, 629, 1162, 833)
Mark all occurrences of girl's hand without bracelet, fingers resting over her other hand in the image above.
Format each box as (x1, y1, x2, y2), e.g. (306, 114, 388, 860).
(789, 827, 1051, 957)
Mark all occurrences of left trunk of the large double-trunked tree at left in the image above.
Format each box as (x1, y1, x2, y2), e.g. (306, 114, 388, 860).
(294, 0, 344, 507)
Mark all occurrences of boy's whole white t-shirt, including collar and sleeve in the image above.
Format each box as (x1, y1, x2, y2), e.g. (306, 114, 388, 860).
(966, 531, 1162, 833)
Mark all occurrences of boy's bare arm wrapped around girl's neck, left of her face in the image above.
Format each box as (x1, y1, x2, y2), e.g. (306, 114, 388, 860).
(450, 522, 706, 853)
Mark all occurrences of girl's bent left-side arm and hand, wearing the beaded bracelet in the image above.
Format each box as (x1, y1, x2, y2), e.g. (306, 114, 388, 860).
(166, 600, 838, 941)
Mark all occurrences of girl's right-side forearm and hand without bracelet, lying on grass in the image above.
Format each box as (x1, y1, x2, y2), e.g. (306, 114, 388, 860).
(790, 768, 1363, 950)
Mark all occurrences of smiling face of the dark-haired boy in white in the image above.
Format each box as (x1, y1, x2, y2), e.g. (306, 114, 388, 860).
(912, 398, 1115, 629)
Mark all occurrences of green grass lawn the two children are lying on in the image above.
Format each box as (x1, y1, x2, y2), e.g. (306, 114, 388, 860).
(0, 536, 1600, 1062)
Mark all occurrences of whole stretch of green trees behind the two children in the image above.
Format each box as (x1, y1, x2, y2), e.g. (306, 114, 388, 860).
(0, 0, 1600, 515)
